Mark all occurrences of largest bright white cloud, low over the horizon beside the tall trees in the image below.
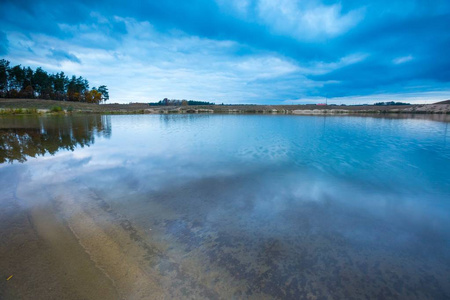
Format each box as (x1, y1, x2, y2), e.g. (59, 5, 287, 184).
(7, 15, 306, 103)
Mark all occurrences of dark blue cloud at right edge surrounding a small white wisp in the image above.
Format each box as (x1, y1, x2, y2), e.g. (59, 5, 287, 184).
(311, 14, 450, 96)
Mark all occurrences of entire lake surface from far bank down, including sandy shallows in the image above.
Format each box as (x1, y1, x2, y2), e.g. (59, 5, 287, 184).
(0, 115, 450, 299)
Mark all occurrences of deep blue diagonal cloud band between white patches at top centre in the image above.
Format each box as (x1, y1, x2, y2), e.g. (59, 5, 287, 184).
(94, 0, 330, 60)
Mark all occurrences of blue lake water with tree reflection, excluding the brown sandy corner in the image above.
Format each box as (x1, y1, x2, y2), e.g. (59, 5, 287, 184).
(0, 115, 450, 299)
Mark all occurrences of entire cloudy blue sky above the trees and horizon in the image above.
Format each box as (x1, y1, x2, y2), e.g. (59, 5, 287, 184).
(0, 0, 450, 104)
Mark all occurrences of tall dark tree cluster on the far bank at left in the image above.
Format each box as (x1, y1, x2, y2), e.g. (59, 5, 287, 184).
(0, 59, 109, 104)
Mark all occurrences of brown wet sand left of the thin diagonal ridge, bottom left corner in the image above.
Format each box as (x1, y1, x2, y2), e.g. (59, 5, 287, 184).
(0, 176, 117, 299)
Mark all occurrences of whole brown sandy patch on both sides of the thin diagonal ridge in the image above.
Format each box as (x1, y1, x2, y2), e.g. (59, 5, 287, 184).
(0, 175, 167, 299)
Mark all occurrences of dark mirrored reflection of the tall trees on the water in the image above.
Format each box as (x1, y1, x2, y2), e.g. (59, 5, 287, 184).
(0, 115, 111, 163)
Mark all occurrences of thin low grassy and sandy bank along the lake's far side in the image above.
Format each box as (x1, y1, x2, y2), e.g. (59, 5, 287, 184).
(0, 99, 450, 115)
